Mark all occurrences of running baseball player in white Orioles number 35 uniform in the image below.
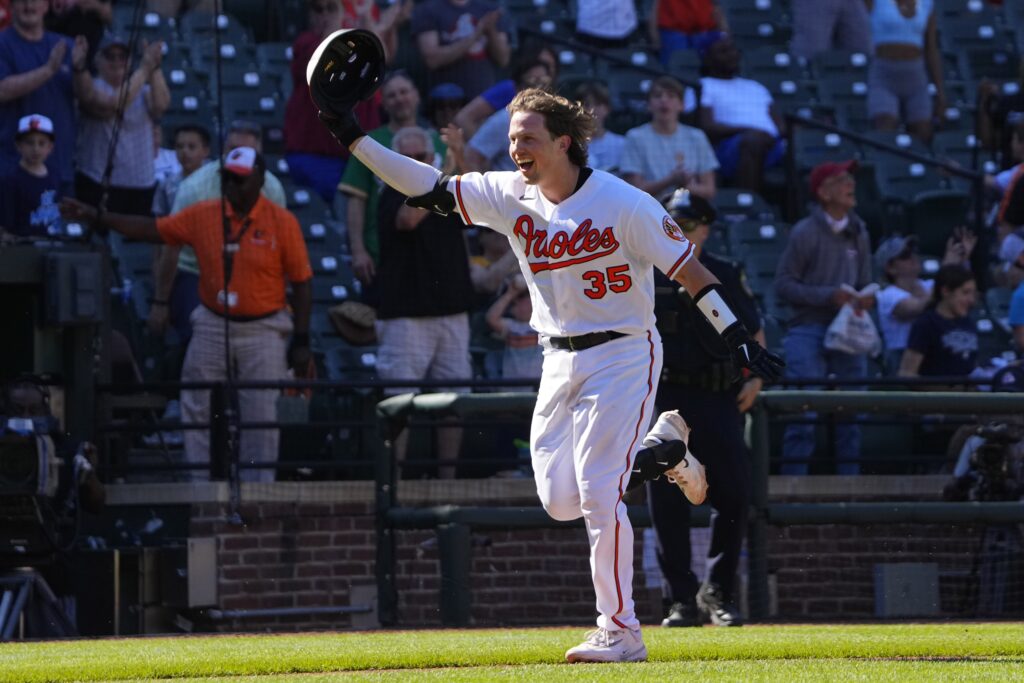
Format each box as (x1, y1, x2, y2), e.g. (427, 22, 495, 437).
(310, 29, 781, 661)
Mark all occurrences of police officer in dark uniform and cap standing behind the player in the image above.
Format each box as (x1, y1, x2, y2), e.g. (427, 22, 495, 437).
(647, 189, 765, 626)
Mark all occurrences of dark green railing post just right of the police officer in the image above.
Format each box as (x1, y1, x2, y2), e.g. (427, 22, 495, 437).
(746, 399, 770, 622)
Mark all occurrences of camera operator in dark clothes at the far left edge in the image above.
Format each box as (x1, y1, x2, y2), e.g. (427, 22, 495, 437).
(0, 377, 106, 637)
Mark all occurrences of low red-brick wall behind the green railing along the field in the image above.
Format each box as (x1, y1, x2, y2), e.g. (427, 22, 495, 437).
(108, 477, 1024, 630)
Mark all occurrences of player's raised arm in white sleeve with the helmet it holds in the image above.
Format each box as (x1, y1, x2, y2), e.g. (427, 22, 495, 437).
(306, 29, 455, 215)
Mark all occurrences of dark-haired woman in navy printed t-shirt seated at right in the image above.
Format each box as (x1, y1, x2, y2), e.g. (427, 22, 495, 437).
(899, 264, 978, 377)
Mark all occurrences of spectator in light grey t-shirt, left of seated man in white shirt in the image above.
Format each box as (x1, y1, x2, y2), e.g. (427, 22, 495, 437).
(620, 76, 718, 202)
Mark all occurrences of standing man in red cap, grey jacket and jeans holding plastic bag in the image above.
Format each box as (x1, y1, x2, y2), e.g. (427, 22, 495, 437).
(775, 161, 874, 474)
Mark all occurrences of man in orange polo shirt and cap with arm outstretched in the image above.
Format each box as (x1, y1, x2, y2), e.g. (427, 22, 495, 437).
(60, 147, 312, 481)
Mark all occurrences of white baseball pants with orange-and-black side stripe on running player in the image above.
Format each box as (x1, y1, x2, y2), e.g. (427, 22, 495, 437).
(530, 331, 662, 630)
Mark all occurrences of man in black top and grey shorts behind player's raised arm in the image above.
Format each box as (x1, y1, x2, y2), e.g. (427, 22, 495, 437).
(377, 126, 473, 478)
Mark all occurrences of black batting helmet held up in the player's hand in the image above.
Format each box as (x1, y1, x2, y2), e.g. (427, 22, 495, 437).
(306, 29, 384, 116)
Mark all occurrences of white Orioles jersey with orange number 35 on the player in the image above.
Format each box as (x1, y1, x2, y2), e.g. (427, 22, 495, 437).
(449, 166, 693, 337)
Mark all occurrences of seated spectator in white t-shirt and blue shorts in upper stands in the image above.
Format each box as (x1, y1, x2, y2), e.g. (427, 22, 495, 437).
(700, 36, 785, 193)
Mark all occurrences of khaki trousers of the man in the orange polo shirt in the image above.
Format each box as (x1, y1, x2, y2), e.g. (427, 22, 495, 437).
(181, 306, 292, 481)
